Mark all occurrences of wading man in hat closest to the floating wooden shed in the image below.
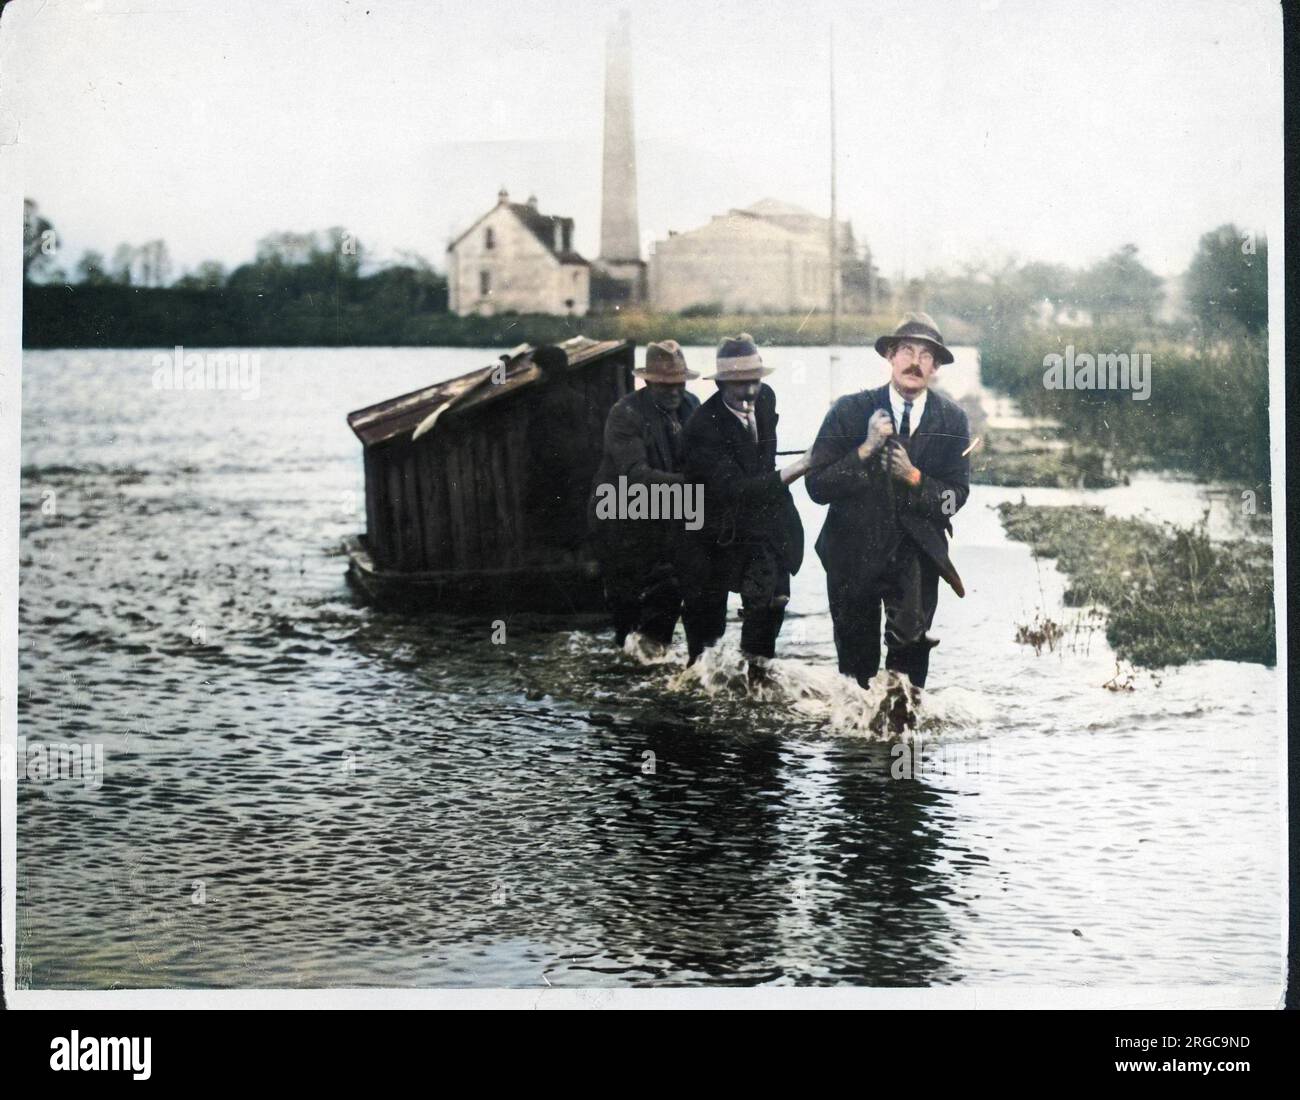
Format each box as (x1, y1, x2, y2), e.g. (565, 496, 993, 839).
(588, 339, 699, 648)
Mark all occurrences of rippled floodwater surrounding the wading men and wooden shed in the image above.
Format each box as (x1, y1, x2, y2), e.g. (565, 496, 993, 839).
(17, 348, 1284, 989)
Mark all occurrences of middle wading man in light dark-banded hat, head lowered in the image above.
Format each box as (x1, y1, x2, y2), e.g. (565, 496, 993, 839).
(681, 333, 809, 681)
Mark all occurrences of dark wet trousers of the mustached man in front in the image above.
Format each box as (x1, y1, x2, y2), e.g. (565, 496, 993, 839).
(827, 538, 939, 688)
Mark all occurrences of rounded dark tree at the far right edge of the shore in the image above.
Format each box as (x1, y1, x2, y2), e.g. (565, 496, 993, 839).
(1184, 224, 1269, 333)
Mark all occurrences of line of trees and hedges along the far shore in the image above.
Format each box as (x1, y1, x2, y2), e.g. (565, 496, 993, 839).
(23, 199, 1268, 347)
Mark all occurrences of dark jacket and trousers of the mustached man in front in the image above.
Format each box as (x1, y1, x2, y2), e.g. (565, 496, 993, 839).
(807, 385, 970, 687)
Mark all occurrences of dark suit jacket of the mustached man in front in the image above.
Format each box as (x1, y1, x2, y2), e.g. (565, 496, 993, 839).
(807, 384, 970, 596)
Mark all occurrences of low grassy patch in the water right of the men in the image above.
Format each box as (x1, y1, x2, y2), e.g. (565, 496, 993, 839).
(998, 503, 1277, 668)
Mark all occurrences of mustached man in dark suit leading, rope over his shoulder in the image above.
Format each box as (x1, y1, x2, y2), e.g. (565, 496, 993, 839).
(807, 313, 970, 688)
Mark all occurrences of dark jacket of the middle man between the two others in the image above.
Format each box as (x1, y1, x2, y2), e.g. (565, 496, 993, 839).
(685, 385, 803, 573)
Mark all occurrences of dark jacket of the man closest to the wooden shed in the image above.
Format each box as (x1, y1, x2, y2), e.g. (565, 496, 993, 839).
(586, 387, 699, 558)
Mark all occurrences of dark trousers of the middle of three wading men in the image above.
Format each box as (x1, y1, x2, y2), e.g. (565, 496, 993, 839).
(680, 543, 790, 659)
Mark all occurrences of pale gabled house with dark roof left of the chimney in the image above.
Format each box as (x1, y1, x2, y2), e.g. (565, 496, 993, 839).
(447, 191, 592, 316)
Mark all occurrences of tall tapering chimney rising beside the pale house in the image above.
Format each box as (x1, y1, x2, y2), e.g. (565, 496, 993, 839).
(597, 12, 645, 304)
